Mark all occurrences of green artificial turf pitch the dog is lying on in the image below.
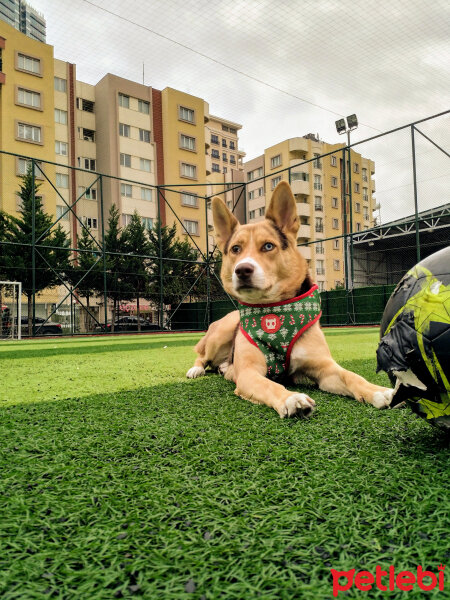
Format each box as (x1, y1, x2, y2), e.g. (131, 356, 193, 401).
(0, 329, 450, 600)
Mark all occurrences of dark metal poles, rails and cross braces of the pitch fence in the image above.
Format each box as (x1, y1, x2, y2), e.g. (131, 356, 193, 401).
(0, 110, 450, 336)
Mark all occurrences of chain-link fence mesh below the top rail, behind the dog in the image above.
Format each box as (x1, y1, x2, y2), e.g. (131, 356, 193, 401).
(0, 112, 450, 336)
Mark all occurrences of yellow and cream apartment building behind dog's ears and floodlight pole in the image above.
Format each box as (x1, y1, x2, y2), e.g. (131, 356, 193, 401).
(244, 134, 375, 290)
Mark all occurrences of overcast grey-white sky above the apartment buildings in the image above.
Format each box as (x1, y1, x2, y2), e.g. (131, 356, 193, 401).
(29, 0, 450, 221)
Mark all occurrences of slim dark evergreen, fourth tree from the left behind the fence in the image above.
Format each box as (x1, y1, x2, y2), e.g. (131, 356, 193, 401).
(122, 211, 150, 331)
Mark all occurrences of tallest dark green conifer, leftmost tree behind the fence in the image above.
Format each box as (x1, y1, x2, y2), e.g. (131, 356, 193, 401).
(6, 168, 70, 335)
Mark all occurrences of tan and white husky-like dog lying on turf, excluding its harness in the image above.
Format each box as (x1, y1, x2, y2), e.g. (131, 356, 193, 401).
(186, 182, 393, 418)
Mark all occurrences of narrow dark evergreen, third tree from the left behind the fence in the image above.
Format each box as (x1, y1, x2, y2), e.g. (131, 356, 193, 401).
(104, 204, 133, 331)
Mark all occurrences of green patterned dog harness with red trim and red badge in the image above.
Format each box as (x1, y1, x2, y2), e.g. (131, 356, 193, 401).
(239, 285, 322, 379)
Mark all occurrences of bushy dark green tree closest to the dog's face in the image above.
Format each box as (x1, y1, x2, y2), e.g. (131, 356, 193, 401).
(148, 223, 198, 324)
